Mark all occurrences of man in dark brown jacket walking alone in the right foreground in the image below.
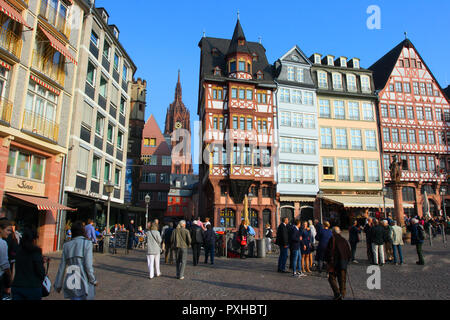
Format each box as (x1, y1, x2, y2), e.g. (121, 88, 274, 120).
(325, 227, 352, 300)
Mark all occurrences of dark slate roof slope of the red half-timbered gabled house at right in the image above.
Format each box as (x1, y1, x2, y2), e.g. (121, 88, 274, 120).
(369, 39, 412, 90)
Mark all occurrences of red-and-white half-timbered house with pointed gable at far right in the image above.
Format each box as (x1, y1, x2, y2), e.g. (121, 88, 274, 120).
(370, 39, 450, 218)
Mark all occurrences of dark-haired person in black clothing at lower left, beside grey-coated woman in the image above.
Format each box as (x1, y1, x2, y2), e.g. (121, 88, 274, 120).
(11, 228, 48, 300)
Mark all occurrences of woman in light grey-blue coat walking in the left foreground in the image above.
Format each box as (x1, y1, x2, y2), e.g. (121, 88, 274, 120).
(54, 221, 98, 300)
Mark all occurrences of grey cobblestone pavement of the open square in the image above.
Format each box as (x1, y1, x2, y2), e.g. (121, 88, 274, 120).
(46, 232, 450, 300)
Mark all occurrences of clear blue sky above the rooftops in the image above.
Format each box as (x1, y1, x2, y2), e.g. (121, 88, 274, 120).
(96, 0, 450, 168)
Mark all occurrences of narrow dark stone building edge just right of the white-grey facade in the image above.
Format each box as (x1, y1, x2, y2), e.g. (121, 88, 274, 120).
(124, 78, 147, 221)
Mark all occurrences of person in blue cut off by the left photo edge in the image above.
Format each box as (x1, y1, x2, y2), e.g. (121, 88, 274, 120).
(0, 219, 12, 300)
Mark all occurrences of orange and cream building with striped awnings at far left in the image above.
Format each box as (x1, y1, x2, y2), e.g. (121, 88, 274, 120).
(0, 0, 89, 253)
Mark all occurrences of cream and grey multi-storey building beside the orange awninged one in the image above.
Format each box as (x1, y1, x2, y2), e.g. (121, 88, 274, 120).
(64, 7, 136, 232)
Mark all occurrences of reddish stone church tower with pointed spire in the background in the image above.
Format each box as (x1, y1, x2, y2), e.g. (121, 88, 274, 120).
(164, 70, 192, 174)
